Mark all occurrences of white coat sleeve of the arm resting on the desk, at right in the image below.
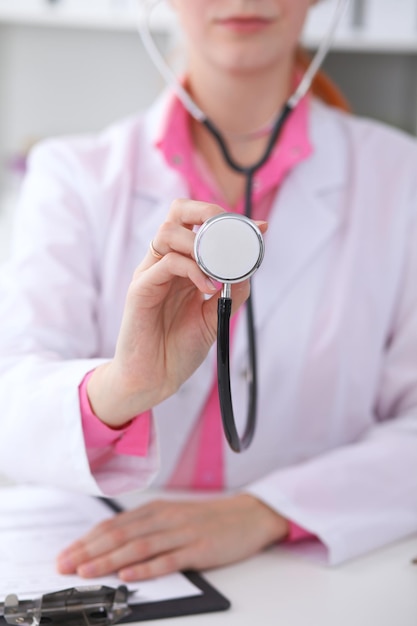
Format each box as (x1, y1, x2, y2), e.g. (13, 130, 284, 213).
(247, 193, 417, 564)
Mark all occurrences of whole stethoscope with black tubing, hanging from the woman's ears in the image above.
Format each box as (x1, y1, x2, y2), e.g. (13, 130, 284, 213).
(138, 0, 349, 452)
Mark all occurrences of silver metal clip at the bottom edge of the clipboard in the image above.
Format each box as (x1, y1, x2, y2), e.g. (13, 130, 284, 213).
(0, 585, 135, 626)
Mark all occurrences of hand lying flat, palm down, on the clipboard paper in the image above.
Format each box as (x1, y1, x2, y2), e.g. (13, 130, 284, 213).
(57, 494, 289, 581)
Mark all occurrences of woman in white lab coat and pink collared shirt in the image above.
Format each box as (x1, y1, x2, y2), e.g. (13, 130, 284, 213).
(0, 0, 417, 580)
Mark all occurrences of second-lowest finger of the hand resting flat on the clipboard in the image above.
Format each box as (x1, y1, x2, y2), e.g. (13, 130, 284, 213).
(76, 528, 191, 578)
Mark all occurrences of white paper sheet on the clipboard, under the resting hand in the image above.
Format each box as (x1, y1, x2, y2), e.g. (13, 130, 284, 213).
(0, 486, 202, 603)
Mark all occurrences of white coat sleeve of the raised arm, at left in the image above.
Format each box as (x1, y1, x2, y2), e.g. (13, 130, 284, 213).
(0, 142, 158, 496)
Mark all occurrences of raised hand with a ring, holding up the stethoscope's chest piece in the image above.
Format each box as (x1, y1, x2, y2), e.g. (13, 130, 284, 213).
(89, 199, 266, 427)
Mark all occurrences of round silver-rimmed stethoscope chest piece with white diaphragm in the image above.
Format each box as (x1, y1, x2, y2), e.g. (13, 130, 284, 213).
(194, 213, 265, 283)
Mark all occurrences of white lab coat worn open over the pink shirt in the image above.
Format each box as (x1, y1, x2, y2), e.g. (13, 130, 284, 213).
(0, 98, 417, 563)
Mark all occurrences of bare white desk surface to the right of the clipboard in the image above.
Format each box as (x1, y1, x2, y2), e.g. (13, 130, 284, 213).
(134, 536, 417, 626)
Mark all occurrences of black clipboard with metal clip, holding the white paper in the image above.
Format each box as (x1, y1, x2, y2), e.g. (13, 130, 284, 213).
(0, 490, 231, 626)
